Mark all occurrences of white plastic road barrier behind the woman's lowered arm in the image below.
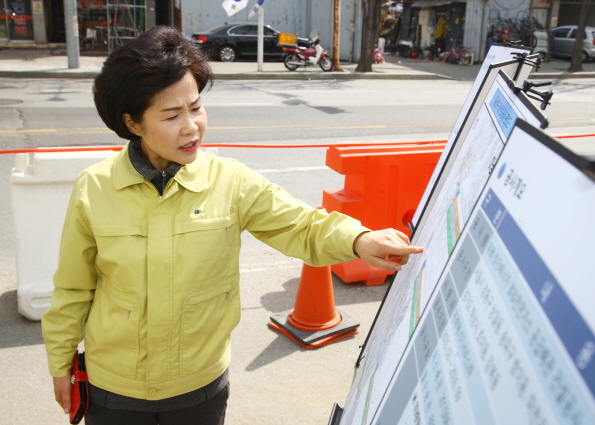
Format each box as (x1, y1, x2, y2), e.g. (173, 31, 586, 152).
(10, 151, 115, 320)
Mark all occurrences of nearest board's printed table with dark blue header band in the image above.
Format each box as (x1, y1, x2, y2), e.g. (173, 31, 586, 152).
(372, 122, 595, 425)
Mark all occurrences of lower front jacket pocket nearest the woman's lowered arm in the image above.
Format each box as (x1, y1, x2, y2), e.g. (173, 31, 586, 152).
(85, 277, 140, 379)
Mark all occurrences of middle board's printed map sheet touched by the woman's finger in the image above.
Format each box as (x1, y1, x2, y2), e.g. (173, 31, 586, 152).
(341, 73, 545, 425)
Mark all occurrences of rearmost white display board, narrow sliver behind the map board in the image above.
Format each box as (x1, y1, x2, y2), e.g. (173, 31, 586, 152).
(412, 45, 539, 227)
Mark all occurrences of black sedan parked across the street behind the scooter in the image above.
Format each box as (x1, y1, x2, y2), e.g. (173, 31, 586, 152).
(192, 22, 311, 62)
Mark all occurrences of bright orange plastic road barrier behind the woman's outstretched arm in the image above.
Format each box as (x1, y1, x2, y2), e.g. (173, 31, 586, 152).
(322, 143, 445, 286)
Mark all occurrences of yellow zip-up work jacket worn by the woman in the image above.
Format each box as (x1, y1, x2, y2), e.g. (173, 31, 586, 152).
(42, 144, 368, 400)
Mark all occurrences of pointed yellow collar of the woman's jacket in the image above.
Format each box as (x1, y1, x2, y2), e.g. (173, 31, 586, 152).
(113, 142, 210, 192)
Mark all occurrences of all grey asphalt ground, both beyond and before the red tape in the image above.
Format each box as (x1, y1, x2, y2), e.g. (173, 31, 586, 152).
(0, 79, 595, 425)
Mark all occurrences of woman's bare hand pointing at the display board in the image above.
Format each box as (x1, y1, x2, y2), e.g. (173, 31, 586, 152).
(353, 229, 424, 271)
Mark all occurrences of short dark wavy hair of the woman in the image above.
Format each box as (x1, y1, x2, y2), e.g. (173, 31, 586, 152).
(93, 26, 214, 140)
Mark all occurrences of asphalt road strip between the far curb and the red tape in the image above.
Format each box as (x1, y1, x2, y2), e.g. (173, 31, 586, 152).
(0, 79, 595, 147)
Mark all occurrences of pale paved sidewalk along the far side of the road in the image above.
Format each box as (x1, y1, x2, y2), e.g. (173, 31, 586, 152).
(0, 48, 595, 81)
